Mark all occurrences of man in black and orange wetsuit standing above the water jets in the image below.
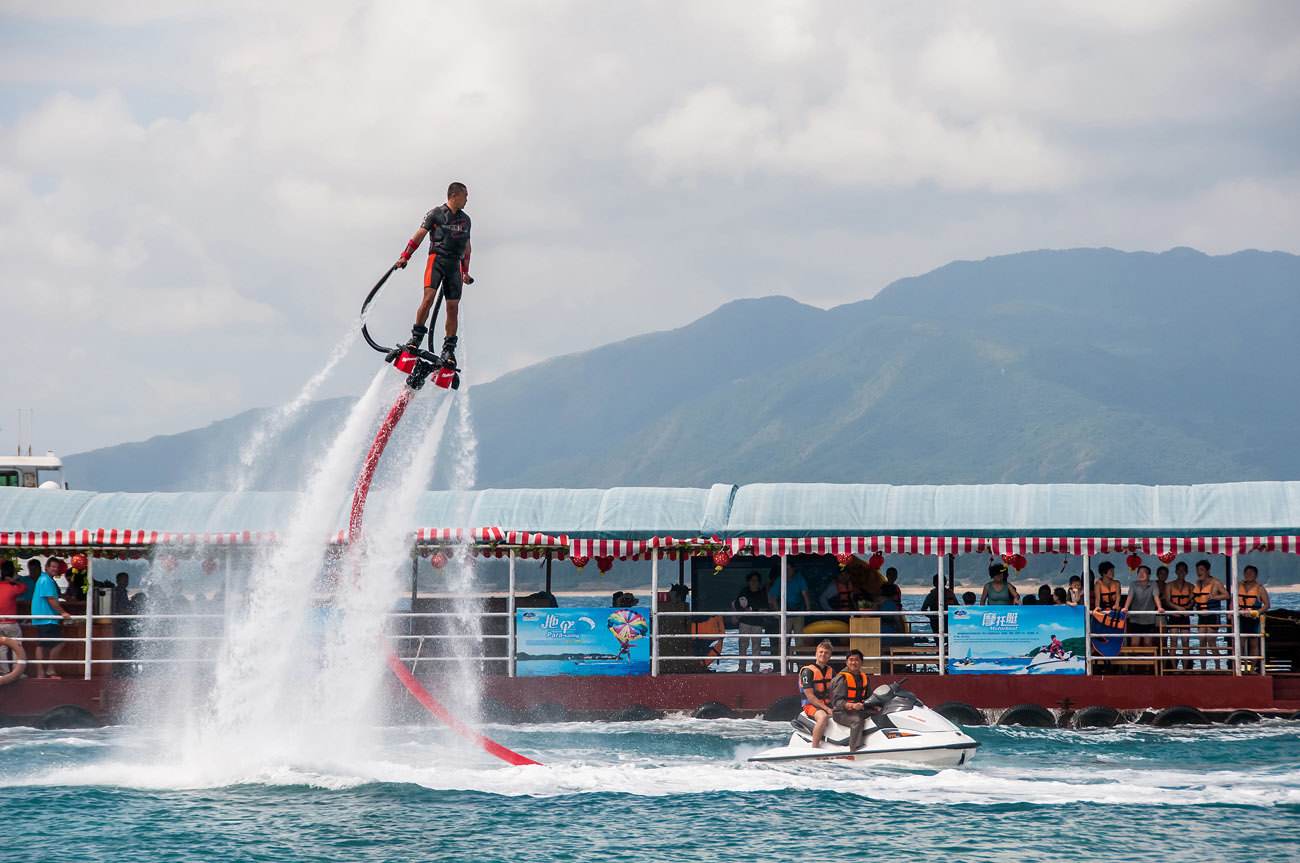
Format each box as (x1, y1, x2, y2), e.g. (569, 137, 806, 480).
(397, 183, 475, 365)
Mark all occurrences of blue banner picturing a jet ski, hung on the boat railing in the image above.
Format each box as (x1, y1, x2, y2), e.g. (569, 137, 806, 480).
(948, 606, 1086, 675)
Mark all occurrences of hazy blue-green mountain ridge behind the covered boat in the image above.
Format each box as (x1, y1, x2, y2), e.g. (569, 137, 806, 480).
(68, 250, 1300, 489)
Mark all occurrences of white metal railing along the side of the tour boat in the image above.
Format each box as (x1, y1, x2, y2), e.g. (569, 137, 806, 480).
(0, 552, 1268, 680)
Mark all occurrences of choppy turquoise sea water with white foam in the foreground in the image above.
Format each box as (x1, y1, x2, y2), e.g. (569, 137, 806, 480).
(0, 717, 1300, 863)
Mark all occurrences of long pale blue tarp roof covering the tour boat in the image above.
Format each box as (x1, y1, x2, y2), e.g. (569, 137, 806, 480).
(0, 482, 1300, 539)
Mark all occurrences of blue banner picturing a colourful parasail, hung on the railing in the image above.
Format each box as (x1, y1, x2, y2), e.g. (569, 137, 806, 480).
(515, 606, 650, 677)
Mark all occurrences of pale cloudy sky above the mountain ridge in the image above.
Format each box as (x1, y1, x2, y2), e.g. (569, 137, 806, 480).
(0, 0, 1300, 452)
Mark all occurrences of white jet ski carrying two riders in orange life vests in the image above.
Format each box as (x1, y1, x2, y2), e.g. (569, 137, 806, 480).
(749, 681, 979, 768)
